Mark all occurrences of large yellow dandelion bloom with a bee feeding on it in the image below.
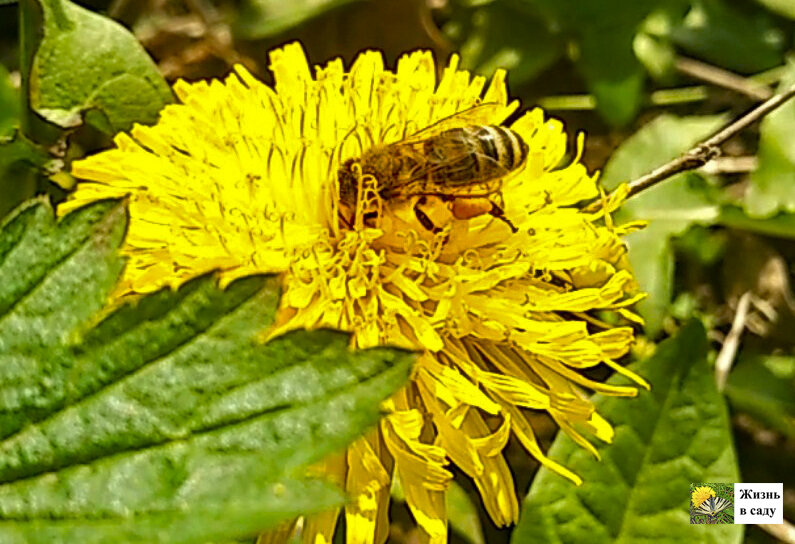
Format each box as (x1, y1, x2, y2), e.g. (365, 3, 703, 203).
(61, 44, 645, 543)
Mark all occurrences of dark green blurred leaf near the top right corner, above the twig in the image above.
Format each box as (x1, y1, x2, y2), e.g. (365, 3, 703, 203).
(671, 0, 785, 74)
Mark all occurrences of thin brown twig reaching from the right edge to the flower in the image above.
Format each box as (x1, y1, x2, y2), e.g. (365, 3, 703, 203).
(584, 85, 795, 213)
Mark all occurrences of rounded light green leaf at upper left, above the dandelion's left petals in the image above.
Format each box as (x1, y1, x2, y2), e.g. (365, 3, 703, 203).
(20, 0, 172, 133)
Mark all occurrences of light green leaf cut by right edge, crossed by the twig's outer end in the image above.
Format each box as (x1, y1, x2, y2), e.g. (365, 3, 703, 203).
(745, 63, 795, 217)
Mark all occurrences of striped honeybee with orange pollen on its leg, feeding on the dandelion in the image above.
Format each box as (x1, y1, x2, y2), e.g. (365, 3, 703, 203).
(337, 103, 528, 233)
